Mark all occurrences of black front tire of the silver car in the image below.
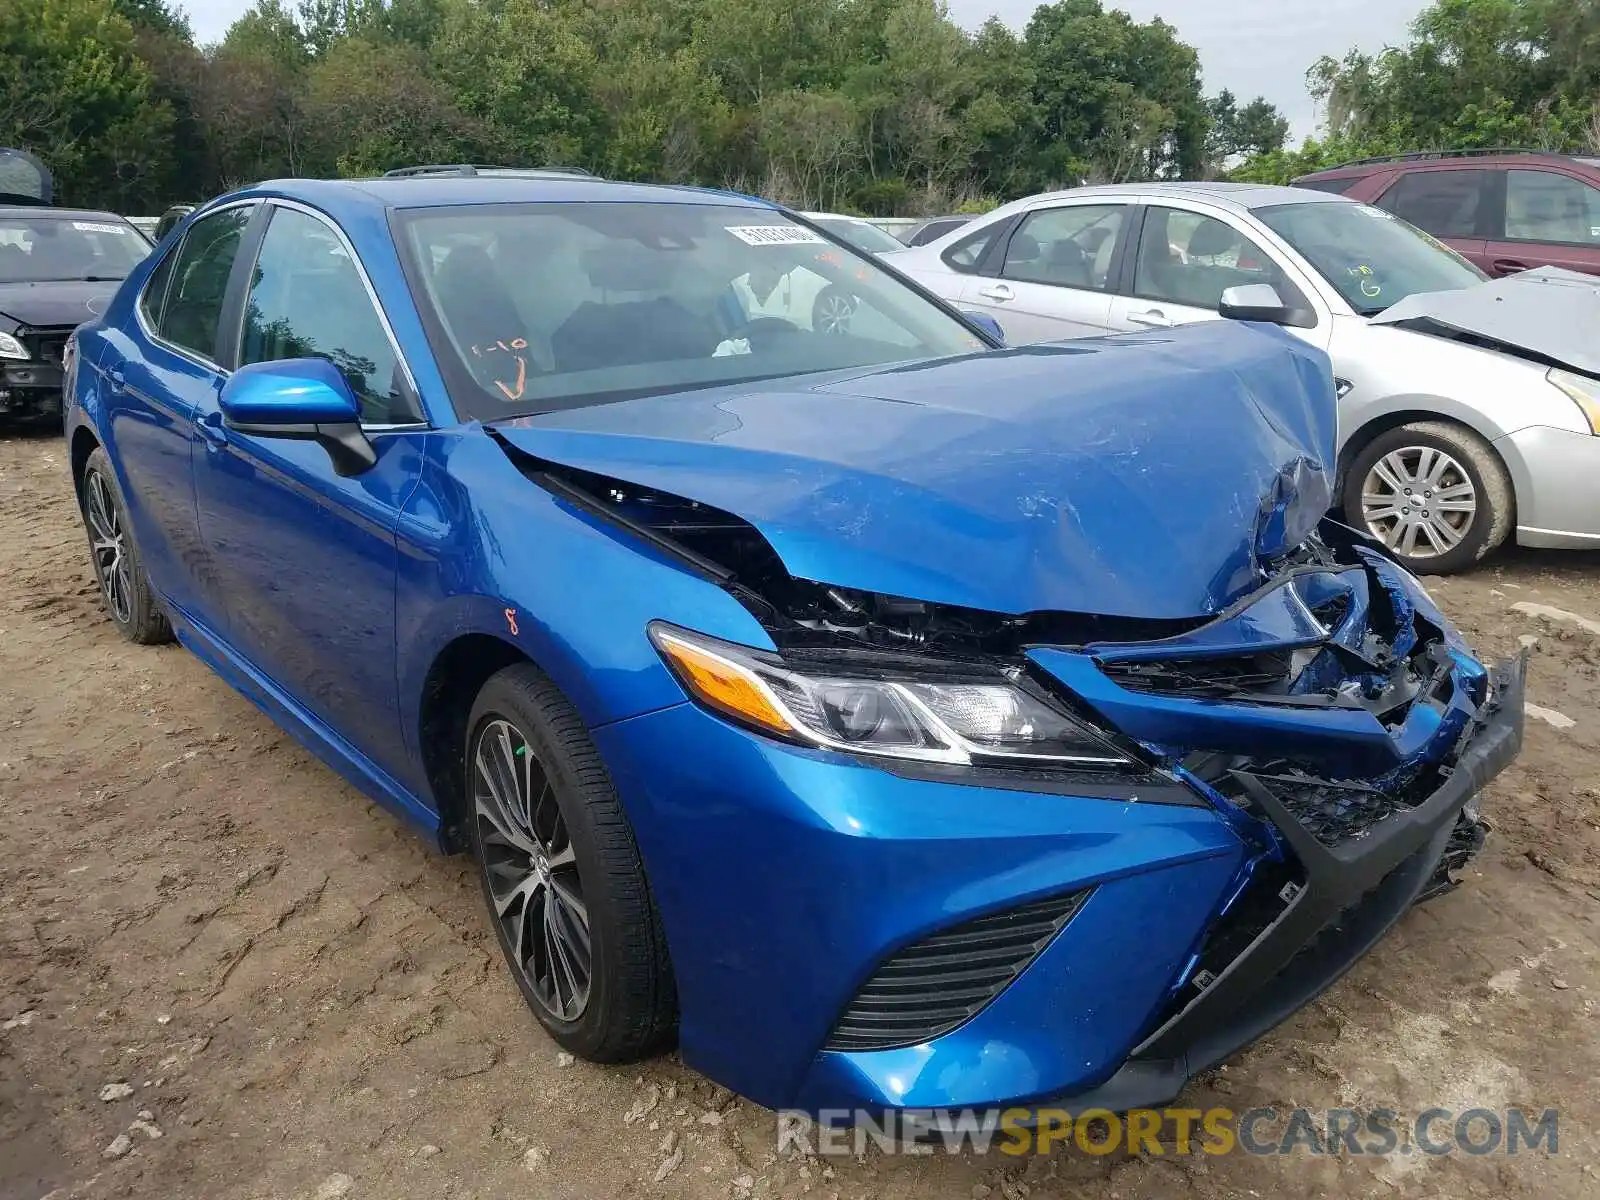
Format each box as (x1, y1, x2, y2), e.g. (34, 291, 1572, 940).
(1342, 421, 1515, 574)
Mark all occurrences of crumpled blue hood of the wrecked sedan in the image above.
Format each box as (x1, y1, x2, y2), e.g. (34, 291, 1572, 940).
(494, 322, 1336, 618)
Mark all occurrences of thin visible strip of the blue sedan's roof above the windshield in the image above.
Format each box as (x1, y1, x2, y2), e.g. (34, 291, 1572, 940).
(234, 173, 773, 208)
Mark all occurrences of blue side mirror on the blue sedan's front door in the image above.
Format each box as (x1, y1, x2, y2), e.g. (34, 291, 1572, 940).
(218, 358, 378, 475)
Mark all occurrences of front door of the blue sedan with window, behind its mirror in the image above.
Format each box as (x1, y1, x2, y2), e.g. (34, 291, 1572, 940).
(195, 205, 426, 778)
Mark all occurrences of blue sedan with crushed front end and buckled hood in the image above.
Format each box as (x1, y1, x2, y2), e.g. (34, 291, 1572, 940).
(66, 173, 1522, 1110)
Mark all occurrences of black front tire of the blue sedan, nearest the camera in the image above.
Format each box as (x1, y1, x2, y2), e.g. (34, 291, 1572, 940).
(464, 664, 678, 1062)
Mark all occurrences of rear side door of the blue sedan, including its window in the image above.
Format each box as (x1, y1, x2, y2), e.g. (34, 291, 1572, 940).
(96, 203, 258, 627)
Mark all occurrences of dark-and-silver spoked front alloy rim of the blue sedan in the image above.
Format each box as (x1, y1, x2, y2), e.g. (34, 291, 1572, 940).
(472, 717, 594, 1022)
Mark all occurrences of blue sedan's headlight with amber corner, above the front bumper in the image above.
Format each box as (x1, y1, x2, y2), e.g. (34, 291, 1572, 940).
(650, 624, 1133, 768)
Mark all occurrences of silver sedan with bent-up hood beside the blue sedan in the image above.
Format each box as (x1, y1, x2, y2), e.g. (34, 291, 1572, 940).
(885, 182, 1600, 574)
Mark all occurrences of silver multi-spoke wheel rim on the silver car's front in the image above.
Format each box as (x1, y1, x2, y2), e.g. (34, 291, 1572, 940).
(1362, 446, 1478, 558)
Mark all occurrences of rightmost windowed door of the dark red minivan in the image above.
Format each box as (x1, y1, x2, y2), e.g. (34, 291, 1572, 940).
(1486, 168, 1600, 275)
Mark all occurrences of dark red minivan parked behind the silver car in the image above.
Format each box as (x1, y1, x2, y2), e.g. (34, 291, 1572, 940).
(1294, 150, 1600, 275)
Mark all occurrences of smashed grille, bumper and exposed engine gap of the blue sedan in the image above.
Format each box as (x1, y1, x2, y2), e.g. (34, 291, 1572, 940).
(506, 445, 1523, 1107)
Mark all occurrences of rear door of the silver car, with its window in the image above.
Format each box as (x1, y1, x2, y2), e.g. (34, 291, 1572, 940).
(960, 202, 1134, 346)
